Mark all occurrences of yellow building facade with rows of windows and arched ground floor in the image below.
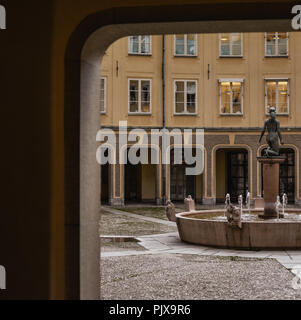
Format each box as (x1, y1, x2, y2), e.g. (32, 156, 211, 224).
(100, 32, 301, 205)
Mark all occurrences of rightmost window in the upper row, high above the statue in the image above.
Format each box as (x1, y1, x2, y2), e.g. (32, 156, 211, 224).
(265, 32, 288, 57)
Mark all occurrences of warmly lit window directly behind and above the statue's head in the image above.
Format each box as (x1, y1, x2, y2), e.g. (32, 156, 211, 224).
(265, 79, 289, 114)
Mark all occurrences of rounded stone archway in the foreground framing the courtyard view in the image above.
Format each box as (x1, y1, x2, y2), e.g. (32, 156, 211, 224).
(65, 3, 291, 299)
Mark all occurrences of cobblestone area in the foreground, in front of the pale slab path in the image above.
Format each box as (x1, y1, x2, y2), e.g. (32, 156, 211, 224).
(102, 253, 301, 300)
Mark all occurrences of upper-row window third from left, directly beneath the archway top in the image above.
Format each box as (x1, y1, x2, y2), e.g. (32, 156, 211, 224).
(219, 33, 243, 57)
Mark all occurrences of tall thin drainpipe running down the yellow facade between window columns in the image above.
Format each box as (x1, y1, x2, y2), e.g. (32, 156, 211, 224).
(162, 35, 166, 205)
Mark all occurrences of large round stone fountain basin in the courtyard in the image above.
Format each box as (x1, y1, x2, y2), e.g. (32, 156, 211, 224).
(176, 209, 301, 250)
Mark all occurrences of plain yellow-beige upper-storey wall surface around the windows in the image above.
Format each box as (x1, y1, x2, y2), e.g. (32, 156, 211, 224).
(102, 33, 301, 128)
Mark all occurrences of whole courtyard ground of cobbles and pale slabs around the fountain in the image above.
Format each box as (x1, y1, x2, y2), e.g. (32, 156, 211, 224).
(100, 206, 301, 300)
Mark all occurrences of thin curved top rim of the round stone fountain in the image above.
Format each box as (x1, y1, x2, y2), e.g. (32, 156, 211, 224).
(176, 208, 301, 225)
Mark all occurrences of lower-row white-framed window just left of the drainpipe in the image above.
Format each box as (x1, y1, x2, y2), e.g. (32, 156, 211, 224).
(129, 79, 152, 114)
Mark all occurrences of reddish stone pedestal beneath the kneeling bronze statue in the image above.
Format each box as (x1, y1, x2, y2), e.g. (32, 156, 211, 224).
(257, 156, 285, 219)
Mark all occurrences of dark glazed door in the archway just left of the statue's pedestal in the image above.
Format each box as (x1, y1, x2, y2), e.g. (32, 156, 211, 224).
(227, 151, 249, 202)
